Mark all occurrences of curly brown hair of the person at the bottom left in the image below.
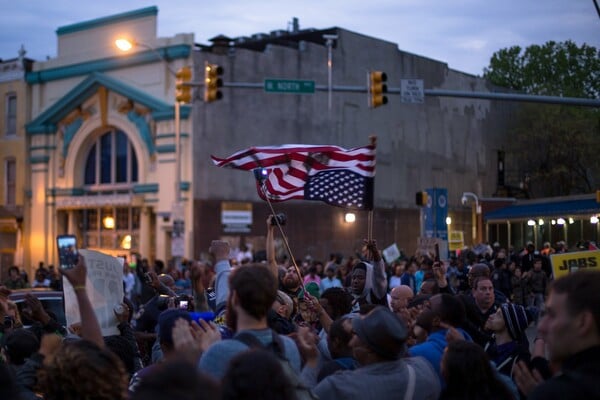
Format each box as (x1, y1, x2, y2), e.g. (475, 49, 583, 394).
(38, 340, 128, 400)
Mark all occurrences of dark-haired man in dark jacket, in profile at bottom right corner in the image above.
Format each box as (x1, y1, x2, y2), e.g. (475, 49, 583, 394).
(515, 271, 600, 400)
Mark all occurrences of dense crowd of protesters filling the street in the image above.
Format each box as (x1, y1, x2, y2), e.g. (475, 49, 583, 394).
(0, 217, 600, 400)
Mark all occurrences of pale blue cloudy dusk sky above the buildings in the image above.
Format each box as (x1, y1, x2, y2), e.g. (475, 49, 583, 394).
(0, 0, 600, 75)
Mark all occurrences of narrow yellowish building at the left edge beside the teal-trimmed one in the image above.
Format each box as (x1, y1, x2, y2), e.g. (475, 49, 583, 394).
(0, 48, 32, 280)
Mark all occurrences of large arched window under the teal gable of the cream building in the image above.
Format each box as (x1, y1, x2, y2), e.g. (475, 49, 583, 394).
(84, 129, 138, 190)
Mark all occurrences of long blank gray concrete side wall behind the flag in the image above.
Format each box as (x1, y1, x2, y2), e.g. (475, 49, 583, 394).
(194, 29, 512, 257)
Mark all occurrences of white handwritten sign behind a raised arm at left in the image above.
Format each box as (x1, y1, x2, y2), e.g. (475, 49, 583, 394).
(63, 250, 123, 336)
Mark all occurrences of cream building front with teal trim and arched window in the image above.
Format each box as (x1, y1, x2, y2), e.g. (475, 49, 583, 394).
(26, 7, 194, 263)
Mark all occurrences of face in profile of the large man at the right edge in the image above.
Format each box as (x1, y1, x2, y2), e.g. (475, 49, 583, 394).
(538, 291, 577, 362)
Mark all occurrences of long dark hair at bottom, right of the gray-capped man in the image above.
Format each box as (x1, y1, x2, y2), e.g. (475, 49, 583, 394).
(442, 340, 513, 400)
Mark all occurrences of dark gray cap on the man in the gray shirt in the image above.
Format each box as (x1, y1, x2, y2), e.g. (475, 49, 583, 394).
(352, 307, 408, 360)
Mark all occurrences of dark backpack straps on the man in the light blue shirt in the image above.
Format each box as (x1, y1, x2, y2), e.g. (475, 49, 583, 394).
(232, 331, 318, 400)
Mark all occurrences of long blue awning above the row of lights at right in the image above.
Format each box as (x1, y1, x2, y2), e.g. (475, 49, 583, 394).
(483, 196, 600, 222)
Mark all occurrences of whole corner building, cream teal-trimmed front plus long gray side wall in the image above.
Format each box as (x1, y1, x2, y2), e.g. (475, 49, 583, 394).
(17, 7, 514, 272)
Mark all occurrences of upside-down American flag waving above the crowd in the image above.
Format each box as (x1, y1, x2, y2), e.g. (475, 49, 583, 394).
(211, 144, 375, 210)
